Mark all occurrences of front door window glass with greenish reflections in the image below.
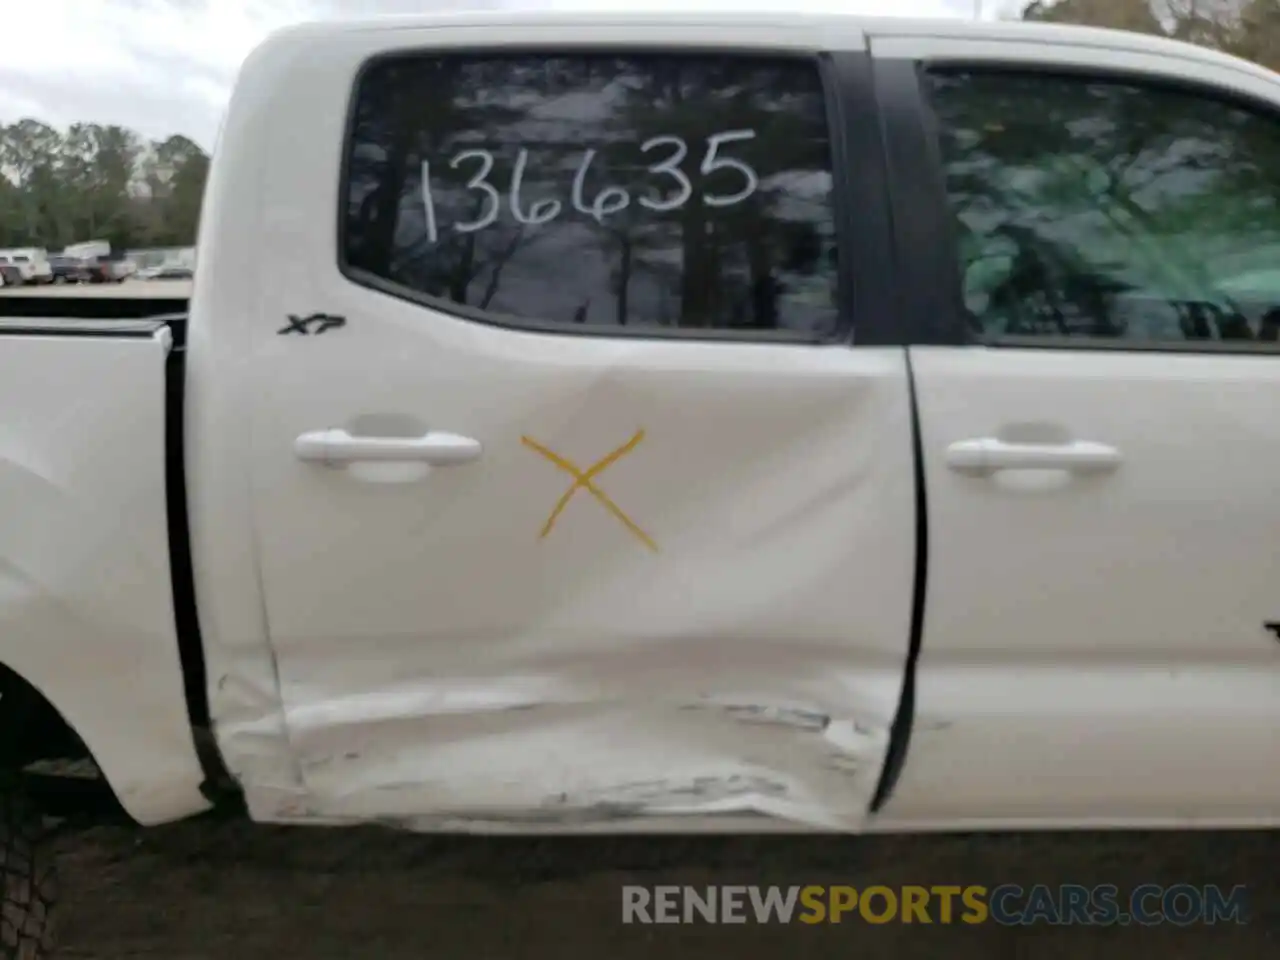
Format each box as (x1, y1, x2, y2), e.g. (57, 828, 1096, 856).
(931, 73, 1280, 342)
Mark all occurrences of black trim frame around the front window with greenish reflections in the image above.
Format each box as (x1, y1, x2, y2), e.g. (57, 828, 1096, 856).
(876, 55, 1280, 356)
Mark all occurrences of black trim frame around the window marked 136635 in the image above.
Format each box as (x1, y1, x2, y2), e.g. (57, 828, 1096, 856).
(334, 44, 904, 346)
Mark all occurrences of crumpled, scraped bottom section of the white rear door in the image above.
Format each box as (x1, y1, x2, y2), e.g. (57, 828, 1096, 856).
(280, 684, 888, 832)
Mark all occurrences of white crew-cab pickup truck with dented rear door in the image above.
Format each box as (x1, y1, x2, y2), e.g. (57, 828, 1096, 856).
(0, 5, 1280, 957)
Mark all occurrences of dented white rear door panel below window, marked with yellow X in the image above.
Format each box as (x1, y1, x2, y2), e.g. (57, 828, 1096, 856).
(246, 309, 915, 831)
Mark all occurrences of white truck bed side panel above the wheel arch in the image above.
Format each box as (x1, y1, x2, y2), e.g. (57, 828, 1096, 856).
(0, 329, 207, 823)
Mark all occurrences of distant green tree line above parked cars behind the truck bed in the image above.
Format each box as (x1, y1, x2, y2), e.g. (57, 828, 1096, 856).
(0, 118, 209, 251)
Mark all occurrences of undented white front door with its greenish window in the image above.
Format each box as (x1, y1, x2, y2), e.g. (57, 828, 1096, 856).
(873, 33, 1280, 827)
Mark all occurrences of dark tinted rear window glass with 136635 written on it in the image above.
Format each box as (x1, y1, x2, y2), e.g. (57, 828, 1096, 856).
(344, 55, 836, 333)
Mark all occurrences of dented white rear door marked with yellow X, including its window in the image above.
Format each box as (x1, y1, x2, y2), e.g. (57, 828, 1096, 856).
(227, 18, 916, 829)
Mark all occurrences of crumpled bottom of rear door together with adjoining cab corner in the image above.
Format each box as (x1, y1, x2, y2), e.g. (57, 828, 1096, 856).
(216, 641, 900, 833)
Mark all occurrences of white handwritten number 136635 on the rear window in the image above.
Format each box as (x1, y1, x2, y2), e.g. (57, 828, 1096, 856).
(422, 131, 760, 243)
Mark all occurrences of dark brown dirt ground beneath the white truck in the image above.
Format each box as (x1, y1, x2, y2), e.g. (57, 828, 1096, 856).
(45, 823, 1280, 960)
